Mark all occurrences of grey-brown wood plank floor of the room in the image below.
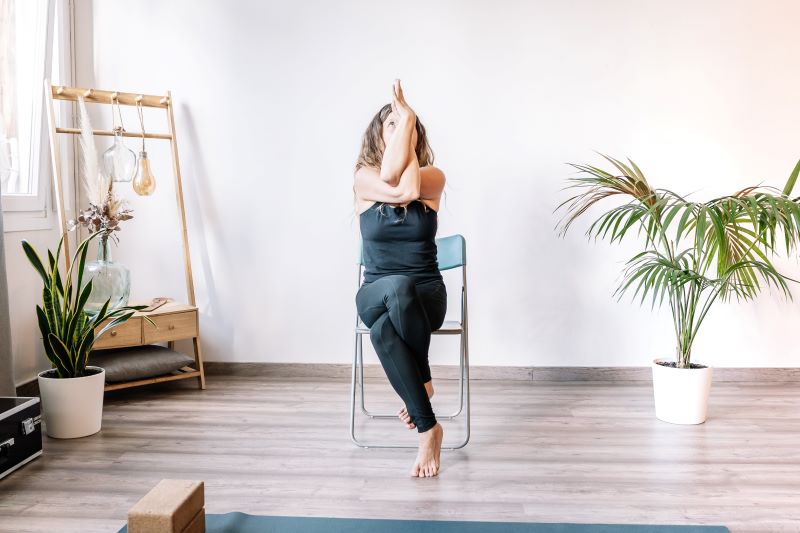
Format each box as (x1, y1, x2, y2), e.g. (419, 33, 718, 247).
(0, 376, 800, 533)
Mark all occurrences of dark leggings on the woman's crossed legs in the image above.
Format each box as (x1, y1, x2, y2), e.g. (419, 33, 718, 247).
(356, 275, 447, 433)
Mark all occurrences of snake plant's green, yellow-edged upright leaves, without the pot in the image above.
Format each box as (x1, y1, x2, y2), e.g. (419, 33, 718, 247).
(22, 231, 146, 378)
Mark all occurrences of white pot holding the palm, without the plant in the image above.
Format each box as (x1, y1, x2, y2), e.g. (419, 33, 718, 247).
(653, 359, 711, 424)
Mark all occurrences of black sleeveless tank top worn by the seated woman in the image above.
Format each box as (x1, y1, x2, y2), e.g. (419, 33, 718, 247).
(359, 200, 442, 283)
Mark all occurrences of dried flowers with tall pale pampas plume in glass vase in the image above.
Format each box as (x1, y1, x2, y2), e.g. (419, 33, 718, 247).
(69, 97, 133, 242)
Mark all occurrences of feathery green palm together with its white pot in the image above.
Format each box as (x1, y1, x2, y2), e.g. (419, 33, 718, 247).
(557, 155, 800, 424)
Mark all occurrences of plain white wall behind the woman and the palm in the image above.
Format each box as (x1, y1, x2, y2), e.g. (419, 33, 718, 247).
(14, 0, 800, 382)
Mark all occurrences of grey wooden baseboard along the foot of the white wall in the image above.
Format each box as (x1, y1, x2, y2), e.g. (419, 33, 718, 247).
(205, 362, 800, 382)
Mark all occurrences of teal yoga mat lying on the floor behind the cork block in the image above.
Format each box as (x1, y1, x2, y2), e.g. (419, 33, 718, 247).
(119, 513, 730, 533)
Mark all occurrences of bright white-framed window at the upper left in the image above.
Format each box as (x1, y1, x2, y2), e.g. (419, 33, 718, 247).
(0, 0, 59, 213)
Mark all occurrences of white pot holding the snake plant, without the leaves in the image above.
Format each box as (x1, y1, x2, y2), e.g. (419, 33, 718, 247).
(39, 366, 106, 439)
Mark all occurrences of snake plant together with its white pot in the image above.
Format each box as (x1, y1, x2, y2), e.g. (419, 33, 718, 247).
(22, 232, 145, 439)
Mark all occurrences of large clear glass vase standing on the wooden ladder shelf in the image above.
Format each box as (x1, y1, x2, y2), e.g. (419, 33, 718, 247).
(83, 235, 131, 315)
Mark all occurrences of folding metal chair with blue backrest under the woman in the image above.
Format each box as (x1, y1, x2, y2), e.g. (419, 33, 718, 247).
(350, 235, 470, 450)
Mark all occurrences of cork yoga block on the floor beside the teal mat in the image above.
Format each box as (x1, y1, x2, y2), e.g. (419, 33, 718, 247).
(128, 479, 205, 533)
